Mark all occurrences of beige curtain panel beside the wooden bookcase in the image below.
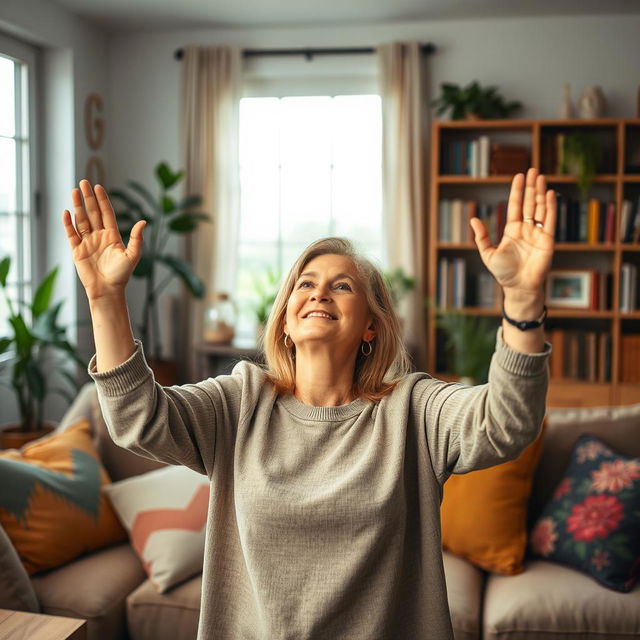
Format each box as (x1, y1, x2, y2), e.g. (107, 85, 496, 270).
(377, 42, 429, 370)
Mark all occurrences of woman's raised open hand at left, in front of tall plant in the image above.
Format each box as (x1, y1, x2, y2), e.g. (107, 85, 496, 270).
(62, 180, 146, 301)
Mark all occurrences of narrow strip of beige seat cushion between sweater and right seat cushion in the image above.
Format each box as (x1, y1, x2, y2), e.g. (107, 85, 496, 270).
(442, 551, 485, 640)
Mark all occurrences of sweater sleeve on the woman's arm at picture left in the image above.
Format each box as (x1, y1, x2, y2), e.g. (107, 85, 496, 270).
(88, 340, 255, 477)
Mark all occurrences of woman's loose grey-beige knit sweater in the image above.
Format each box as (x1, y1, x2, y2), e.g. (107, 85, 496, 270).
(89, 328, 551, 640)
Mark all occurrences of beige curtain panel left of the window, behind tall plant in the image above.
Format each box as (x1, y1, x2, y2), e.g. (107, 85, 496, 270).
(182, 46, 242, 381)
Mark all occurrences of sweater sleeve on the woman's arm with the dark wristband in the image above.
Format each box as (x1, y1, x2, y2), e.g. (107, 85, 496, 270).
(418, 327, 551, 482)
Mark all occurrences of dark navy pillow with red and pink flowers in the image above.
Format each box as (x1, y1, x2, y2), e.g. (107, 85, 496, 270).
(529, 433, 640, 592)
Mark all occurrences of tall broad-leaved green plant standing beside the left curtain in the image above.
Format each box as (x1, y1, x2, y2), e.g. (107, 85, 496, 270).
(109, 162, 209, 361)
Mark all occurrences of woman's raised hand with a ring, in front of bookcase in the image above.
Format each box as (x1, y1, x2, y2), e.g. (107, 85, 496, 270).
(470, 168, 556, 296)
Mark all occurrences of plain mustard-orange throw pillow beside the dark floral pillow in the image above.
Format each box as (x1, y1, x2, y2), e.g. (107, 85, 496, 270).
(440, 434, 542, 575)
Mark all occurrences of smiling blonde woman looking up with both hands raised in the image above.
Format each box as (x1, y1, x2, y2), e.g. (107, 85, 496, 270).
(64, 169, 556, 640)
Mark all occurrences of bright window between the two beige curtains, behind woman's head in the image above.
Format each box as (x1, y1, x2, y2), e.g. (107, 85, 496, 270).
(235, 95, 383, 337)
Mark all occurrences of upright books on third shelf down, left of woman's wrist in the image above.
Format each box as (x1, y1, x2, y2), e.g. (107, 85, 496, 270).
(436, 256, 498, 309)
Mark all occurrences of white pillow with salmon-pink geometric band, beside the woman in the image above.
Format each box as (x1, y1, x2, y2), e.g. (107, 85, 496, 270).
(105, 465, 209, 593)
